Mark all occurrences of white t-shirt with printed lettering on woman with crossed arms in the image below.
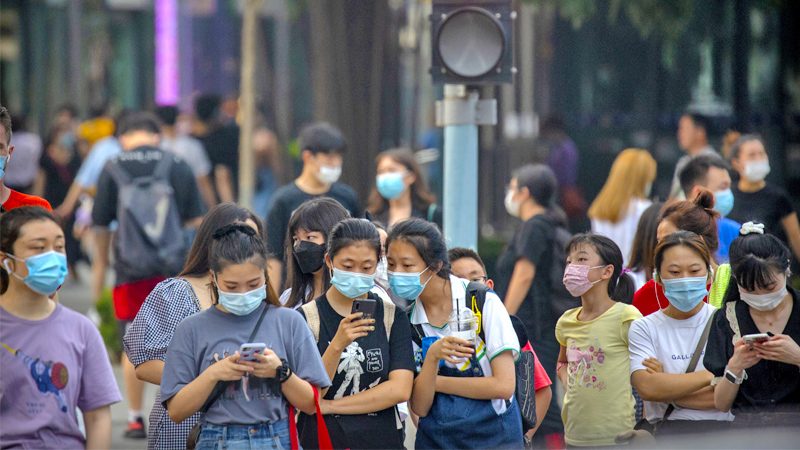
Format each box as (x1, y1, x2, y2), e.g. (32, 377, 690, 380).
(628, 304, 733, 422)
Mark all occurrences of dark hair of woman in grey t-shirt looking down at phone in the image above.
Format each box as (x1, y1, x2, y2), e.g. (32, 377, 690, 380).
(208, 223, 281, 306)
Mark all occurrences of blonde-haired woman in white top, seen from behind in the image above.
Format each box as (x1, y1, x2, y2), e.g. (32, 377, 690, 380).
(588, 148, 656, 263)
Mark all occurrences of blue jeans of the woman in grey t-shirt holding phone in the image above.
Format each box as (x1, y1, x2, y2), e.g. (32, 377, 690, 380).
(197, 419, 291, 450)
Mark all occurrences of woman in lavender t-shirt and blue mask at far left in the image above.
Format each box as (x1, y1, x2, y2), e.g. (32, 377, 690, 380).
(0, 207, 121, 448)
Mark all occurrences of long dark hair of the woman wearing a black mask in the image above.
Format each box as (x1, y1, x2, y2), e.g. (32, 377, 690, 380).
(284, 197, 350, 307)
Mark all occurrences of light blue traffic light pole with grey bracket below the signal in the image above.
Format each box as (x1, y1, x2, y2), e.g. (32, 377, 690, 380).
(436, 84, 497, 250)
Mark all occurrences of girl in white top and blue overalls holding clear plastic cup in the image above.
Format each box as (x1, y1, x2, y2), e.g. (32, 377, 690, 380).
(386, 219, 523, 448)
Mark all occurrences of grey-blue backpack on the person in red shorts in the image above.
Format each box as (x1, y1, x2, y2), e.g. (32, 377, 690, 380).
(106, 154, 187, 280)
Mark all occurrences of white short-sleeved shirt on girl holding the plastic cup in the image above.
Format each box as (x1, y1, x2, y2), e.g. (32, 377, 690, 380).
(409, 275, 519, 415)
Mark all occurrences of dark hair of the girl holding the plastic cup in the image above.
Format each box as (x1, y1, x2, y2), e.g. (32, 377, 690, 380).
(386, 218, 450, 280)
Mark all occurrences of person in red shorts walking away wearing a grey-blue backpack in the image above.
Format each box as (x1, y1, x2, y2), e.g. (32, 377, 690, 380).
(92, 112, 204, 439)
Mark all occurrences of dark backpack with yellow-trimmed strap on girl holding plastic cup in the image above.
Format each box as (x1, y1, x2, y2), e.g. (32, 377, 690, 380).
(408, 281, 536, 431)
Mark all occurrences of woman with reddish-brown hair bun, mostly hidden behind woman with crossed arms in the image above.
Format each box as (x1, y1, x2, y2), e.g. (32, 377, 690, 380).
(633, 189, 731, 316)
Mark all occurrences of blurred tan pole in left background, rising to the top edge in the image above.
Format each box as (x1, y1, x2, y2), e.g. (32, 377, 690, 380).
(239, 0, 261, 208)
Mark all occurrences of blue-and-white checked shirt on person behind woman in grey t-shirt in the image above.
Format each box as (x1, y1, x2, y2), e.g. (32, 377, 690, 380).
(124, 278, 201, 450)
